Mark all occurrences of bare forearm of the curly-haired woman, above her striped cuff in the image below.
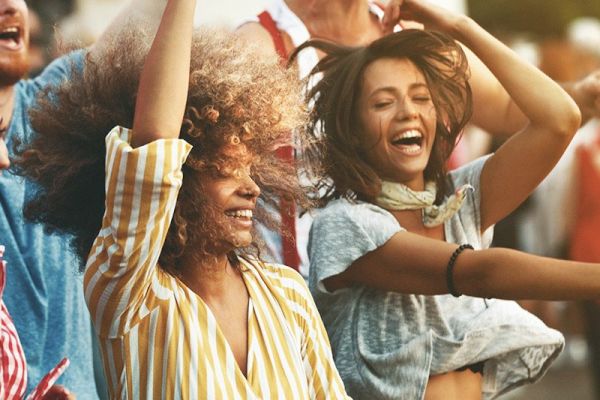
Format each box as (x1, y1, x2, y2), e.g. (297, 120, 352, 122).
(132, 0, 196, 146)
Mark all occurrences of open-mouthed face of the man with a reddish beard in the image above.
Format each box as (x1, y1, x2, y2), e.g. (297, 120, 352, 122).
(0, 0, 29, 86)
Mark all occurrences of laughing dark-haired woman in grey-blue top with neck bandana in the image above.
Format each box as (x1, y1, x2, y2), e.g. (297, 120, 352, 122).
(297, 0, 600, 400)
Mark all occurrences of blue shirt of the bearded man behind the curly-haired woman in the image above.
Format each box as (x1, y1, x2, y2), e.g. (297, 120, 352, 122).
(0, 52, 98, 399)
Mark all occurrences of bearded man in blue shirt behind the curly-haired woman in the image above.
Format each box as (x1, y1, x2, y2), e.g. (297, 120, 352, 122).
(0, 0, 170, 399)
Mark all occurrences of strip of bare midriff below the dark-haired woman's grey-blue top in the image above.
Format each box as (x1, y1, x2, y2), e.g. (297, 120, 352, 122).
(425, 370, 483, 400)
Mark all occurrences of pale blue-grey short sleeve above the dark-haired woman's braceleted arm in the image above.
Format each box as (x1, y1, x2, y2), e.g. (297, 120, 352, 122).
(308, 199, 404, 293)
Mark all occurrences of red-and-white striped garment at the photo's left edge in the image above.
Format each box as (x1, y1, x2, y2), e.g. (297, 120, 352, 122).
(0, 246, 27, 400)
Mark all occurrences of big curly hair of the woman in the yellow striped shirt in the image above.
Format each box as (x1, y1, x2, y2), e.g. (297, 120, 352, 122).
(16, 24, 309, 274)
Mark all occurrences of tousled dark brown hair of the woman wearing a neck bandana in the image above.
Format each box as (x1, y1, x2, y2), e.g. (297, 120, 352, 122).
(291, 29, 472, 204)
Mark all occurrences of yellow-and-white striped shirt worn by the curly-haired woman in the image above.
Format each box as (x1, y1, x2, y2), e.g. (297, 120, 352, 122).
(84, 128, 347, 399)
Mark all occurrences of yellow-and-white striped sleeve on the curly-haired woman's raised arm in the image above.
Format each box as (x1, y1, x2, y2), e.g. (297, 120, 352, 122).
(84, 127, 191, 338)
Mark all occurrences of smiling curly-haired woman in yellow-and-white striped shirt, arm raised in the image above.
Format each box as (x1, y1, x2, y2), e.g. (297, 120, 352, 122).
(20, 0, 346, 399)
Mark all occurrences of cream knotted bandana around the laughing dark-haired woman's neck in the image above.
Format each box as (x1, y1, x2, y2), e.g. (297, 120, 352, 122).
(375, 181, 474, 228)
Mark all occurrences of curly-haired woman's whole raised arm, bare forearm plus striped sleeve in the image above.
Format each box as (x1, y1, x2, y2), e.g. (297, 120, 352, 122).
(84, 0, 195, 337)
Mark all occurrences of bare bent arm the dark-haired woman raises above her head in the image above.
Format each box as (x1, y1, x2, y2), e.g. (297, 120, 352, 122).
(390, 0, 581, 231)
